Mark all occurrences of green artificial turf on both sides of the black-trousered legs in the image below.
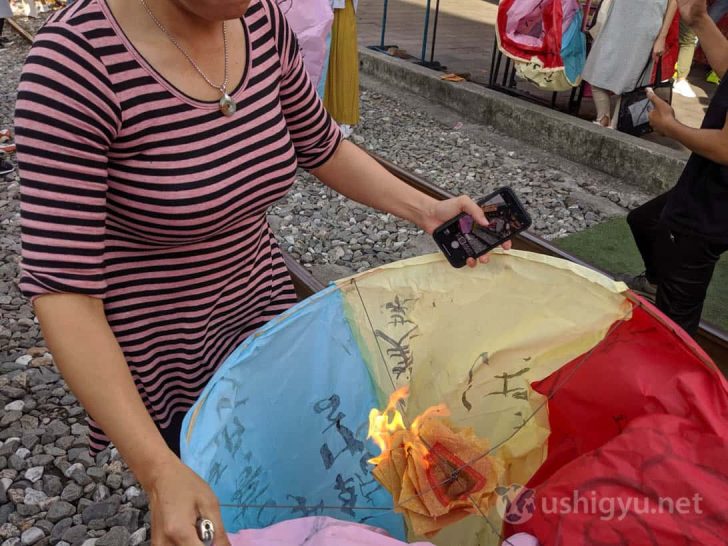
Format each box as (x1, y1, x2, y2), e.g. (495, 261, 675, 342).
(552, 218, 728, 330)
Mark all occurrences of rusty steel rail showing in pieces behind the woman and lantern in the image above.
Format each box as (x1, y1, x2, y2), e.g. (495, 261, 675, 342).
(8, 18, 728, 375)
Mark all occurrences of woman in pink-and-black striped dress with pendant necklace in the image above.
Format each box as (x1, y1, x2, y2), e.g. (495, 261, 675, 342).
(16, 0, 504, 546)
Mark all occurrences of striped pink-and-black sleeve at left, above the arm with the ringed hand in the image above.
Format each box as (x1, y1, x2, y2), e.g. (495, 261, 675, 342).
(15, 23, 120, 300)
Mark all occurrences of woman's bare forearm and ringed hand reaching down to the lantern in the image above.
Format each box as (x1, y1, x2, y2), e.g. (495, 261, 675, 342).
(35, 293, 230, 546)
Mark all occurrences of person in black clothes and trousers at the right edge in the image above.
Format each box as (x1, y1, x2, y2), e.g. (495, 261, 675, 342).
(623, 0, 728, 335)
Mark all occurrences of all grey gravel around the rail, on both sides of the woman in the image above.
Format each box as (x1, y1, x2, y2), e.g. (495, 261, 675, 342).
(0, 10, 645, 546)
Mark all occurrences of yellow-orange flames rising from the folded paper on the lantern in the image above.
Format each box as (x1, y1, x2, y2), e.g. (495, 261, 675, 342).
(367, 386, 450, 465)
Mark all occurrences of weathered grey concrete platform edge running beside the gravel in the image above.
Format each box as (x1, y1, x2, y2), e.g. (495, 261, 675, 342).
(359, 47, 687, 193)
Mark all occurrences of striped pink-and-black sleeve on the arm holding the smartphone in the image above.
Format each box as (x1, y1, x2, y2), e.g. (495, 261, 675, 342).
(269, 1, 342, 171)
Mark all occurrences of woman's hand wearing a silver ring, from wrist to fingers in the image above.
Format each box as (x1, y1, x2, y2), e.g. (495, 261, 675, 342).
(140, 457, 230, 546)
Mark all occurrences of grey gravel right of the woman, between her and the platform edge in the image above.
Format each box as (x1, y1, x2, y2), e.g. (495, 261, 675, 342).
(270, 77, 649, 281)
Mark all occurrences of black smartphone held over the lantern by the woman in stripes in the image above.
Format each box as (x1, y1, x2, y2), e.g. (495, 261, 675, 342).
(432, 187, 531, 268)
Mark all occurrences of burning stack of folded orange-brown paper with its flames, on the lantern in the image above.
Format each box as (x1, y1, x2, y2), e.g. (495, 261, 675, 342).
(369, 387, 503, 537)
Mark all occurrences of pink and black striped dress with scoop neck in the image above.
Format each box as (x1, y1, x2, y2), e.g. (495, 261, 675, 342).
(16, 0, 341, 450)
